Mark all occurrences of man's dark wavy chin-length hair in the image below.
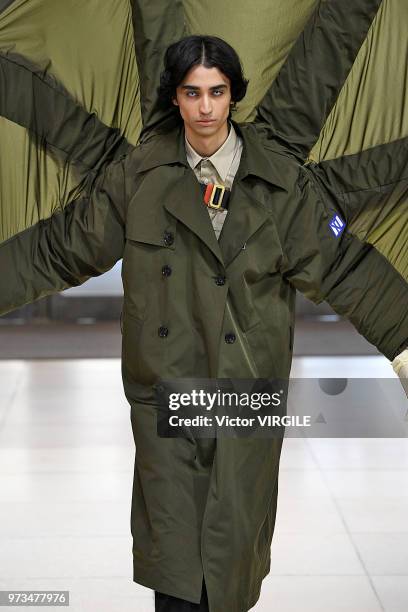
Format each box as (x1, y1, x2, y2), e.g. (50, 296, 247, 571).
(158, 35, 248, 110)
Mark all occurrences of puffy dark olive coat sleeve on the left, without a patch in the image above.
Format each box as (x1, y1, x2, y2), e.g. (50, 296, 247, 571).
(0, 152, 128, 314)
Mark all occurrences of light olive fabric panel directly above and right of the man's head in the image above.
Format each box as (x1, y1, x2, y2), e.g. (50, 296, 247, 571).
(183, 0, 318, 121)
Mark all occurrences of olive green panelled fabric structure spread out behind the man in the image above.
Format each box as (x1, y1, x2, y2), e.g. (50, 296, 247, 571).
(0, 0, 408, 280)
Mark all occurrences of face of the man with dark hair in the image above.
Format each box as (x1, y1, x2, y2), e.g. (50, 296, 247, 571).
(173, 66, 231, 137)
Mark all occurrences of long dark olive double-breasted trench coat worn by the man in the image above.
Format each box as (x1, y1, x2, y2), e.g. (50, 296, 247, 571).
(0, 117, 408, 612)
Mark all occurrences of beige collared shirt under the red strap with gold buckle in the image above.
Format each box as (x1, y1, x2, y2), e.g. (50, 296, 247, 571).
(185, 124, 243, 240)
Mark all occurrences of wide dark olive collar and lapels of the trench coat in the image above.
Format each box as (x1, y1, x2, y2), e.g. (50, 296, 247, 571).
(137, 122, 286, 267)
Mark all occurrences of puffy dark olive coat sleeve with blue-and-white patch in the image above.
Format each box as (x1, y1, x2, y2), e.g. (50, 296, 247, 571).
(273, 155, 408, 360)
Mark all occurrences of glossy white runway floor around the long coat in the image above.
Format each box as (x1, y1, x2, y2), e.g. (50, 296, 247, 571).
(0, 357, 408, 612)
